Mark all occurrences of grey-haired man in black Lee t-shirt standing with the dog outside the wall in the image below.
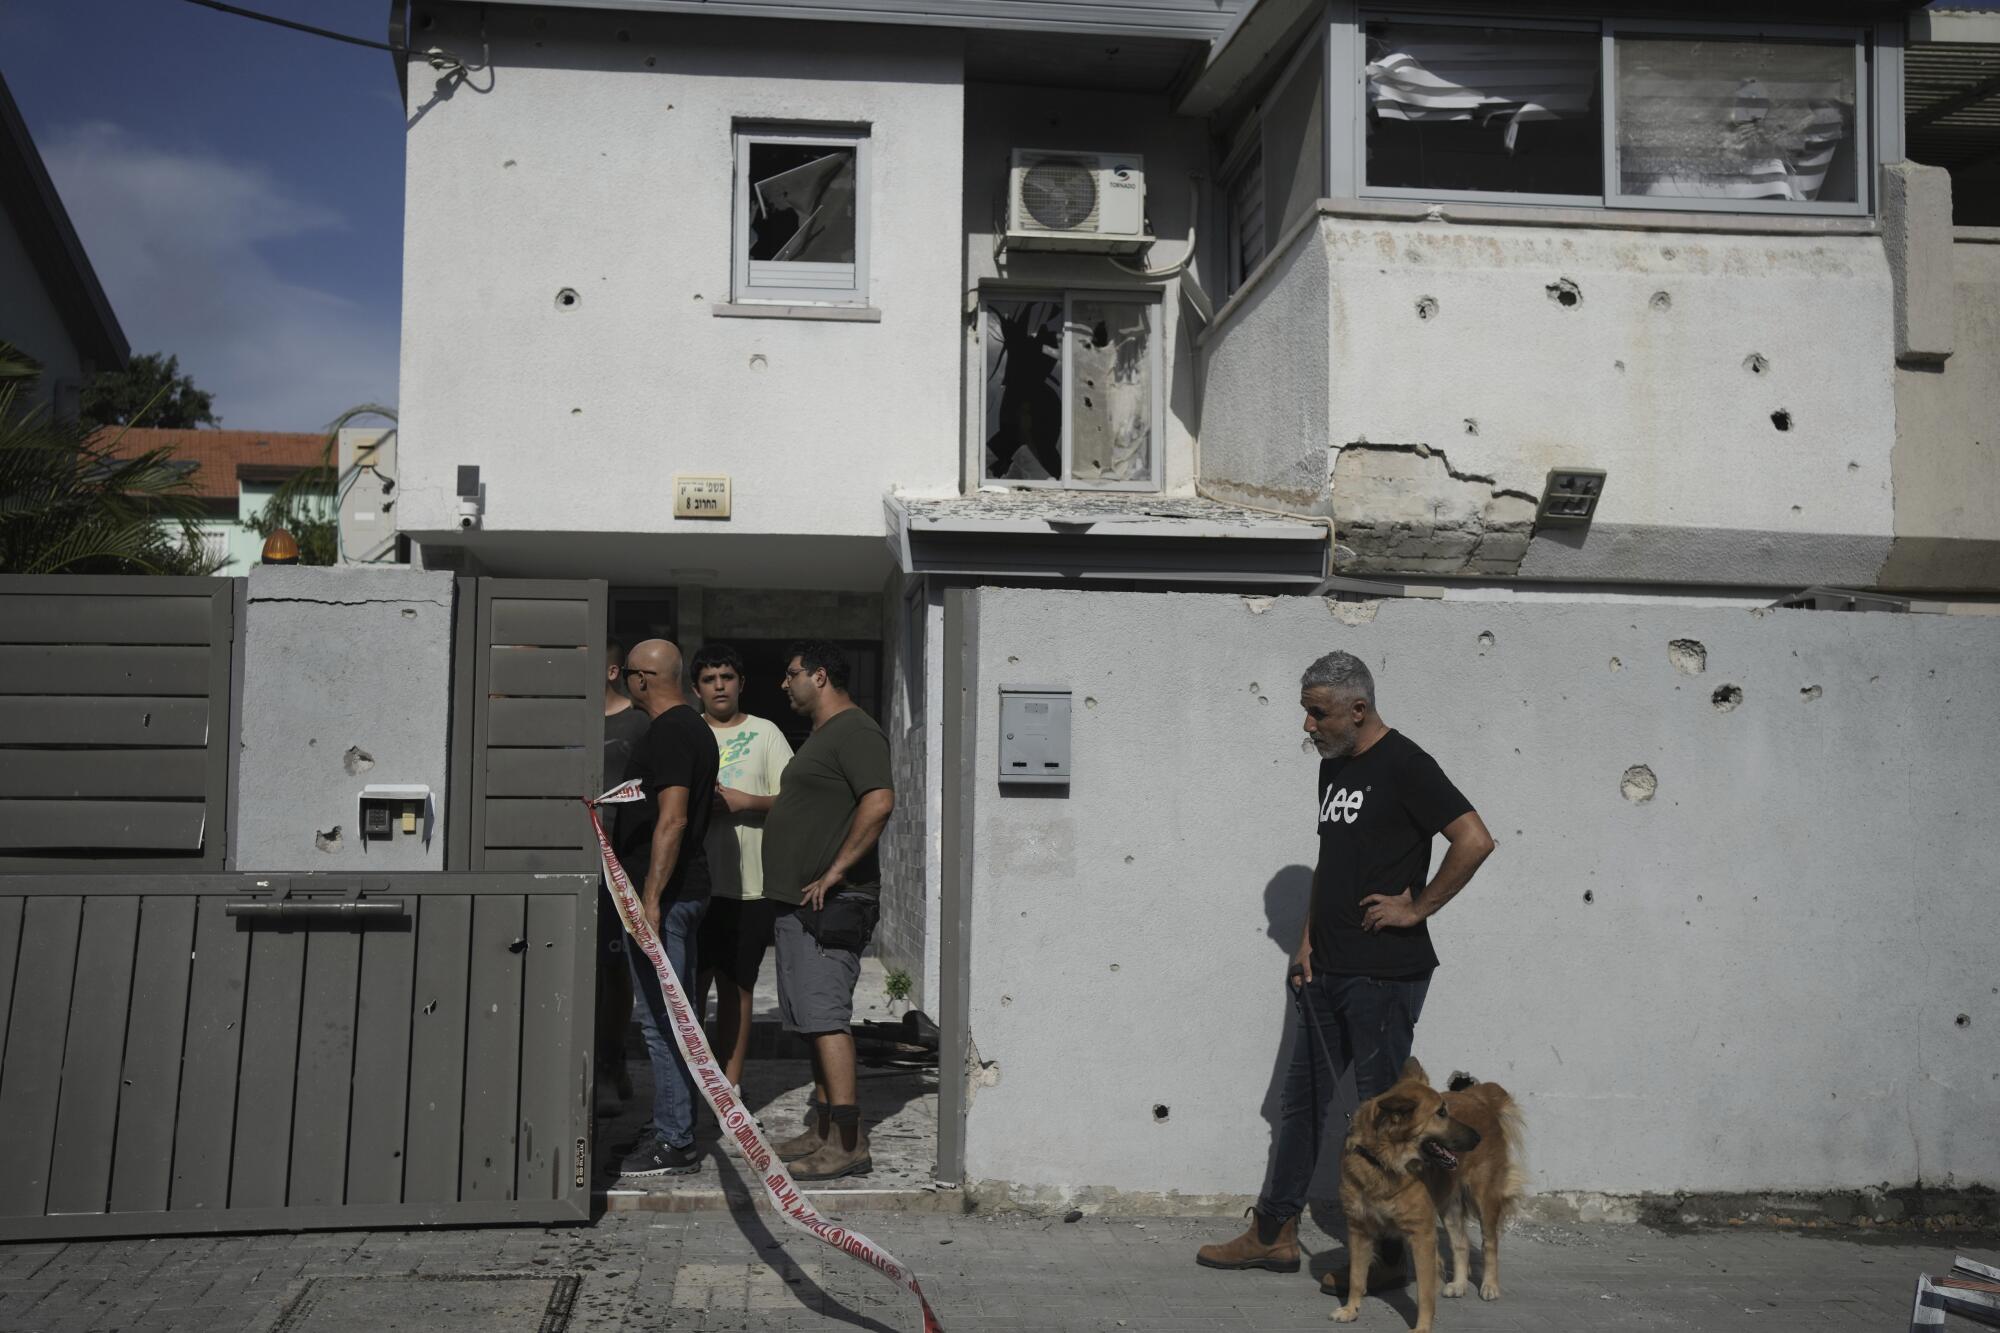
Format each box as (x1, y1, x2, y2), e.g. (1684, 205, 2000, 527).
(1196, 652, 1494, 1287)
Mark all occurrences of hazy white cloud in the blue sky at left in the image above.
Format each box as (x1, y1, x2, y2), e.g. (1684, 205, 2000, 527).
(42, 122, 398, 430)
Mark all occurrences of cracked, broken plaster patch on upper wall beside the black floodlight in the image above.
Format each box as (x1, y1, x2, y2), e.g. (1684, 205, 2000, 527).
(1334, 440, 1536, 576)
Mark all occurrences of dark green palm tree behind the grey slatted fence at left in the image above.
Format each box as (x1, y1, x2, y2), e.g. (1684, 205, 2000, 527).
(0, 378, 216, 574)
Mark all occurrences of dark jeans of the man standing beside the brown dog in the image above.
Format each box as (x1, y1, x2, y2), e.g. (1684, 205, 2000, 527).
(1256, 973, 1430, 1221)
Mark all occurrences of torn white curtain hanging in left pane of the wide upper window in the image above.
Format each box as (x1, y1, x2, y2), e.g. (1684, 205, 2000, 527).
(1366, 40, 1598, 152)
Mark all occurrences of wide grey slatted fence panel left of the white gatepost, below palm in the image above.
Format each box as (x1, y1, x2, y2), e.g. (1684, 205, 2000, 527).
(0, 576, 238, 873)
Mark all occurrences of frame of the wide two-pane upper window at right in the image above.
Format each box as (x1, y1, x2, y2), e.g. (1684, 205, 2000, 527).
(1328, 4, 1882, 218)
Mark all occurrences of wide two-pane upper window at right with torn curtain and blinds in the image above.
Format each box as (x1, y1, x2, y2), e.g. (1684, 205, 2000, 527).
(1358, 16, 1872, 212)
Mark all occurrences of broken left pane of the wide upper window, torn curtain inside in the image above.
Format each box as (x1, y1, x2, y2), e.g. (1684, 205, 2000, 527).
(1364, 22, 1604, 196)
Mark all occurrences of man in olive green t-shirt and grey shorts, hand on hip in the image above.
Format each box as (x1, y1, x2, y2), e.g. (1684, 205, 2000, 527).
(764, 642, 896, 1181)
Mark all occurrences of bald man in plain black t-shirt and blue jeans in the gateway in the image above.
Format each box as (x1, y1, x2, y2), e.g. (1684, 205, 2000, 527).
(612, 638, 718, 1175)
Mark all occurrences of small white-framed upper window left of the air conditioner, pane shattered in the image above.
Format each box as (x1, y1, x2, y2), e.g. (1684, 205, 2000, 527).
(730, 126, 868, 306)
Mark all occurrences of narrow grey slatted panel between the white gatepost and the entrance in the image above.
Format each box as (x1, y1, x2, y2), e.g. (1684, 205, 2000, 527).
(446, 578, 606, 871)
